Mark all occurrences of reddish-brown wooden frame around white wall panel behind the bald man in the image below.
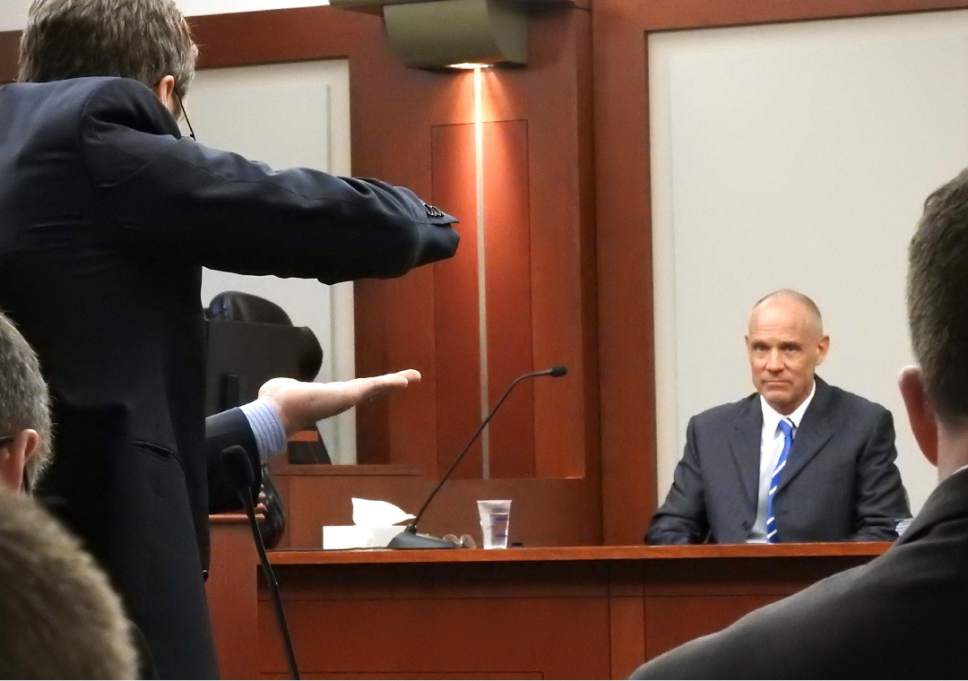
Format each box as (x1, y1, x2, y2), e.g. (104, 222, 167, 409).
(592, 0, 968, 544)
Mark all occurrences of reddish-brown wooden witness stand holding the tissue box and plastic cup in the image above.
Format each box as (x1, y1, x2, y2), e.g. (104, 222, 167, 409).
(210, 532, 889, 678)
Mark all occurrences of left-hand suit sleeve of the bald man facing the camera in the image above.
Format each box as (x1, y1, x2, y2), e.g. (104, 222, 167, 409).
(645, 419, 709, 544)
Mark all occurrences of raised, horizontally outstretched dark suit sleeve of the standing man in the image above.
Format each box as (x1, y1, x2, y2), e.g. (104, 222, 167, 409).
(80, 79, 458, 283)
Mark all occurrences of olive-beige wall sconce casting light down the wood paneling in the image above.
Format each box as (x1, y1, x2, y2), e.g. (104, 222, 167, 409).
(330, 0, 532, 68)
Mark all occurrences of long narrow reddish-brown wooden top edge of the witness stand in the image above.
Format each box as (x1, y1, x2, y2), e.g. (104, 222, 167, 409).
(270, 540, 891, 565)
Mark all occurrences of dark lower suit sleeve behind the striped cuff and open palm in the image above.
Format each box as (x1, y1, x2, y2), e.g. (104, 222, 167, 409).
(205, 409, 262, 513)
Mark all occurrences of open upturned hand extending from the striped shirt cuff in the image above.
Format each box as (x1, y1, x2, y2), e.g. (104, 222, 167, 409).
(259, 369, 420, 437)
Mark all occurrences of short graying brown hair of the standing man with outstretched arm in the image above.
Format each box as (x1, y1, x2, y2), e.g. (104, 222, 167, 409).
(17, 0, 198, 98)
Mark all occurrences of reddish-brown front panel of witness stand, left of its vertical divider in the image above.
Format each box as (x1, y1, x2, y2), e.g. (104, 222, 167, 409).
(259, 564, 609, 679)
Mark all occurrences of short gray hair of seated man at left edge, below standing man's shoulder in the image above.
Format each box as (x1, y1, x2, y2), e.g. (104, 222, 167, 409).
(0, 313, 53, 480)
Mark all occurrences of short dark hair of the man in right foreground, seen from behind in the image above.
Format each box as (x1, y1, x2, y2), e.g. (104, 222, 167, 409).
(907, 170, 968, 425)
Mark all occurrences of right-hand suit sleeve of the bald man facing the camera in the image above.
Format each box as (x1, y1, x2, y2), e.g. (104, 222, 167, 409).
(850, 408, 911, 541)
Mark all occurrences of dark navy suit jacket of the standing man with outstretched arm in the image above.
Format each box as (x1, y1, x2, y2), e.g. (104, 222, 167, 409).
(0, 78, 457, 678)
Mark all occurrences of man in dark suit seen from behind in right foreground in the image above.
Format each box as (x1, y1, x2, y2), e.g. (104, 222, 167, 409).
(634, 171, 968, 679)
